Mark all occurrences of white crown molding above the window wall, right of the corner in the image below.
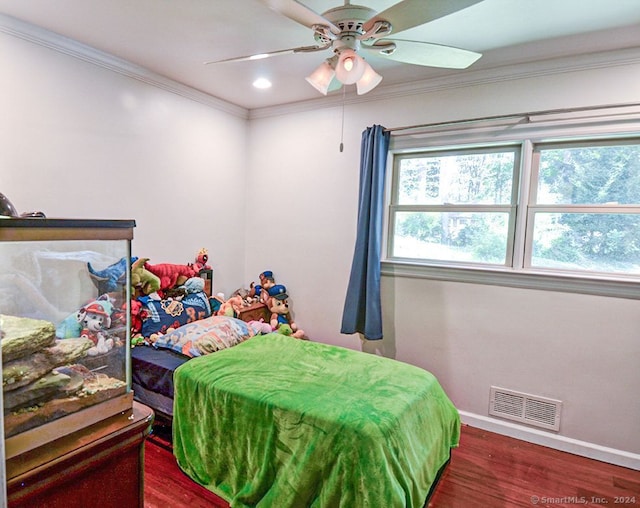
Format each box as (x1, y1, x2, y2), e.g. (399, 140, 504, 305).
(249, 48, 640, 120)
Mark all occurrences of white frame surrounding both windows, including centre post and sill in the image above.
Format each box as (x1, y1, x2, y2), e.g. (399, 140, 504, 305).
(381, 106, 640, 299)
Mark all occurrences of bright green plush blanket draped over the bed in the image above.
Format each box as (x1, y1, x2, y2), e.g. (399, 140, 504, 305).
(173, 334, 460, 508)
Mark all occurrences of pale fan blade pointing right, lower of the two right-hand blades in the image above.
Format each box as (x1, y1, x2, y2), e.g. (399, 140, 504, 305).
(361, 39, 482, 69)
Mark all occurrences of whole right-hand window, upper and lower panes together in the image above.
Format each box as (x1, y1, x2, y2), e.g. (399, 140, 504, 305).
(527, 140, 640, 274)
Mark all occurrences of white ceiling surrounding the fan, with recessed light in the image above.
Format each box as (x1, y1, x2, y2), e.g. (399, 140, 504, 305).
(0, 0, 640, 109)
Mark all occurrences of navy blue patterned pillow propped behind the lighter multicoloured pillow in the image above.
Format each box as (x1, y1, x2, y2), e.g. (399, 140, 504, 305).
(139, 292, 211, 337)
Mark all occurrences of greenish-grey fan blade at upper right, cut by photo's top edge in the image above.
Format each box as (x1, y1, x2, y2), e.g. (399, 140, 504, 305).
(362, 0, 482, 37)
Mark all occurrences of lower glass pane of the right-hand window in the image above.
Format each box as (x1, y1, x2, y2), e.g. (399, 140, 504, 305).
(531, 212, 640, 274)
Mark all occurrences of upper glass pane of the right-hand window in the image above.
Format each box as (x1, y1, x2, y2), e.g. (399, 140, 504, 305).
(537, 145, 640, 204)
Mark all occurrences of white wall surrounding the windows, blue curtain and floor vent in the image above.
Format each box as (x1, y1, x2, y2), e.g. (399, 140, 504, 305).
(247, 52, 640, 460)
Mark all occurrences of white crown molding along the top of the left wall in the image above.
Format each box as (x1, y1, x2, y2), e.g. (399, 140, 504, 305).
(0, 14, 249, 120)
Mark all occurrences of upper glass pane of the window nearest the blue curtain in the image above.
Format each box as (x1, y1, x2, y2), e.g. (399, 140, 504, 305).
(397, 151, 515, 205)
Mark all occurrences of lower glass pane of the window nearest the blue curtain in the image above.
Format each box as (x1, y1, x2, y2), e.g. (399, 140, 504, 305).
(392, 212, 509, 265)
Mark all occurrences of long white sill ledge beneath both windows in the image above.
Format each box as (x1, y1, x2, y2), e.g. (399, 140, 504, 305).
(381, 260, 640, 300)
